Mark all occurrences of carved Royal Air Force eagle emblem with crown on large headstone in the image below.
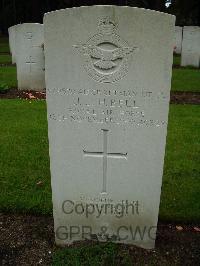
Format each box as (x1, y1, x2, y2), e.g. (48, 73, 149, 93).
(73, 18, 138, 83)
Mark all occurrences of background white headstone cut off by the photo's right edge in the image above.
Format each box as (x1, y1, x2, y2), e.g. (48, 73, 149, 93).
(181, 26, 200, 67)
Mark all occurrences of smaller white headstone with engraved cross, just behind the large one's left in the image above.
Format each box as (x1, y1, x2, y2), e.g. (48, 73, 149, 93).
(15, 23, 45, 90)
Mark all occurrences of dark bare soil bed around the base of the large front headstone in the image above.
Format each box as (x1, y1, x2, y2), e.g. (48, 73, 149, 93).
(0, 214, 200, 266)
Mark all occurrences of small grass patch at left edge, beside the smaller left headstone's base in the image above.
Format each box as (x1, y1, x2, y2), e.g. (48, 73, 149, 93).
(0, 66, 17, 88)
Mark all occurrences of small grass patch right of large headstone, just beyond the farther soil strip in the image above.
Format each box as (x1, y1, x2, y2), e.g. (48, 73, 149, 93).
(172, 68, 200, 92)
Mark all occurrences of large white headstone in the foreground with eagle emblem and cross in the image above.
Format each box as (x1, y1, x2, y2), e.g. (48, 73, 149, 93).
(44, 6, 174, 248)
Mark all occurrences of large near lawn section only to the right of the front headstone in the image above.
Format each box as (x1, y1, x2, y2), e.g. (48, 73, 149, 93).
(159, 105, 200, 223)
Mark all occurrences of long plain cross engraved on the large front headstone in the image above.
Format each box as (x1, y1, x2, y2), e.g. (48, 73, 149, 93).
(83, 129, 127, 193)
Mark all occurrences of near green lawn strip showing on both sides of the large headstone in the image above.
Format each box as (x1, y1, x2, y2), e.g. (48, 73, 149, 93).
(0, 100, 200, 223)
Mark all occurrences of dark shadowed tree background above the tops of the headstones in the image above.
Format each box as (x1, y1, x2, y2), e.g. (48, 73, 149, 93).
(0, 0, 200, 34)
